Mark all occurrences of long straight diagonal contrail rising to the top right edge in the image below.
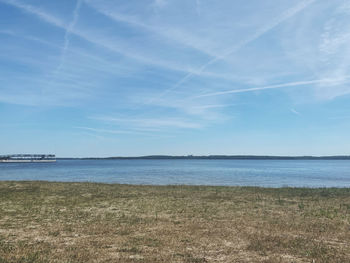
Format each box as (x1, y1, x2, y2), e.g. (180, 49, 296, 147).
(150, 0, 315, 102)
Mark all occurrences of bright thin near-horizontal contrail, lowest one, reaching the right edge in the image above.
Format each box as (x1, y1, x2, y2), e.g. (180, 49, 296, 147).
(195, 77, 349, 98)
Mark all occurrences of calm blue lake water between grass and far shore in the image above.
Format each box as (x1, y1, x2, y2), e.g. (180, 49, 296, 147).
(0, 160, 350, 187)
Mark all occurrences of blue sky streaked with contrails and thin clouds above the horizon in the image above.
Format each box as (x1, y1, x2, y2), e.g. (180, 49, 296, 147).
(0, 0, 350, 157)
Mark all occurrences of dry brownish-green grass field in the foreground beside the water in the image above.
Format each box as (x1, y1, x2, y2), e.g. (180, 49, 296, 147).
(0, 182, 350, 263)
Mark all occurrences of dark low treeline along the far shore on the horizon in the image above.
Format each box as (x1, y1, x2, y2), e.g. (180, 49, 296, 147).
(57, 155, 350, 160)
